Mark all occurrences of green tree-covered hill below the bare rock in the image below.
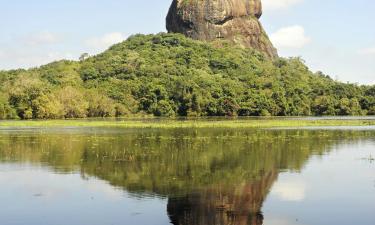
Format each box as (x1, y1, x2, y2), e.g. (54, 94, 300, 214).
(0, 34, 375, 119)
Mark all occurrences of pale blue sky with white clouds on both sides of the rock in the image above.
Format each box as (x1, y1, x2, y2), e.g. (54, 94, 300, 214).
(0, 0, 375, 84)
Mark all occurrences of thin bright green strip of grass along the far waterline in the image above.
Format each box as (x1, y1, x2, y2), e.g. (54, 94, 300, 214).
(0, 118, 375, 129)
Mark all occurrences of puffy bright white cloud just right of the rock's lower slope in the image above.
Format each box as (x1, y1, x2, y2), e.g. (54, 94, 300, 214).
(270, 25, 311, 49)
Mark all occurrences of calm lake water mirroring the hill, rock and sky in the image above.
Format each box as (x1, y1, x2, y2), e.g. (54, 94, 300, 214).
(0, 128, 375, 225)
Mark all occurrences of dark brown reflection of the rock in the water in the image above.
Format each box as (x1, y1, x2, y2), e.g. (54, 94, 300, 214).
(168, 171, 277, 225)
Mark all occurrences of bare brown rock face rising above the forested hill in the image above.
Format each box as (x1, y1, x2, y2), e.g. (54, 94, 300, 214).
(167, 0, 277, 58)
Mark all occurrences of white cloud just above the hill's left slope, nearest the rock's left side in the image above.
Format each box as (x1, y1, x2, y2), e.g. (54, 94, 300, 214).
(86, 32, 126, 51)
